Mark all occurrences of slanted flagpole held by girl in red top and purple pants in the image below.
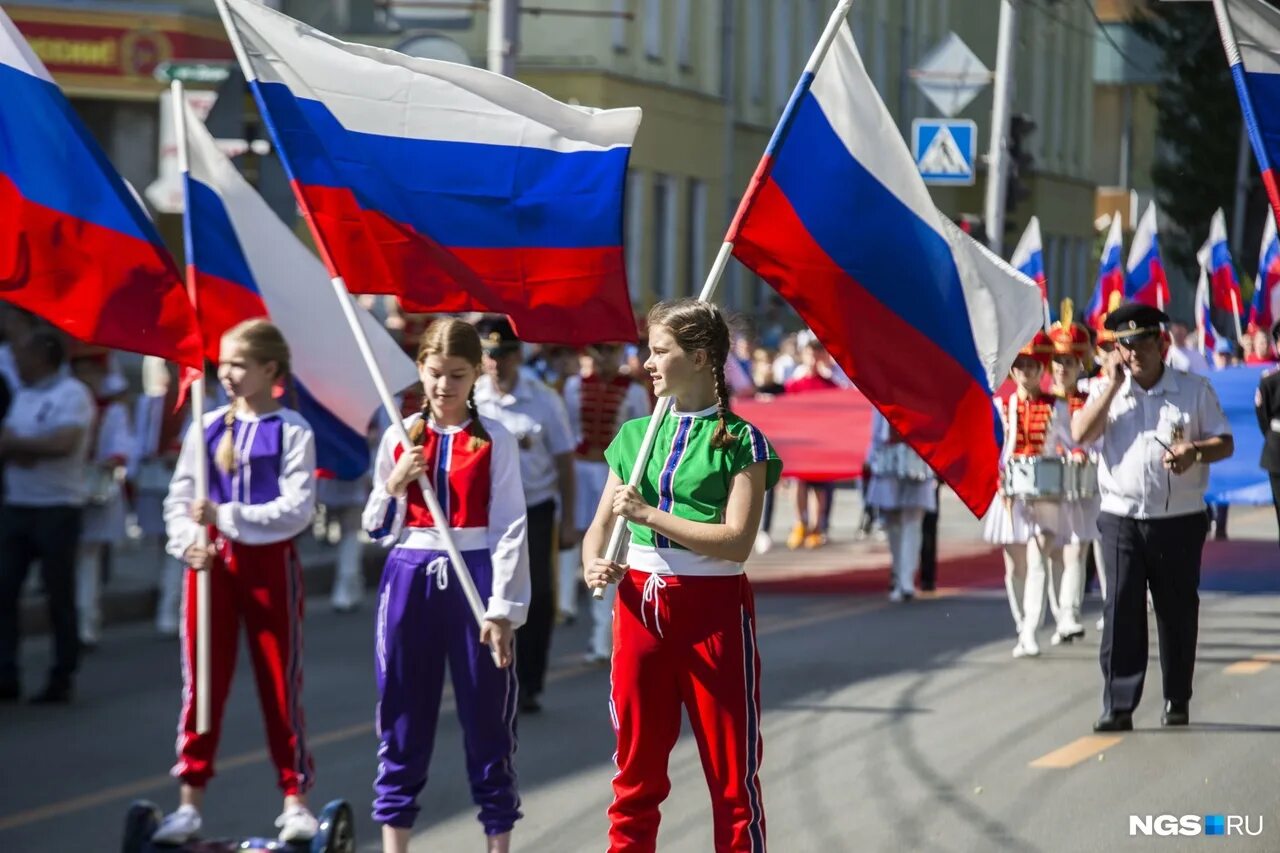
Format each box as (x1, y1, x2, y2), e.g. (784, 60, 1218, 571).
(209, 0, 498, 665)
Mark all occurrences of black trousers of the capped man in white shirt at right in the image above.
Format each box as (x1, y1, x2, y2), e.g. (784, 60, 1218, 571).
(1098, 512, 1208, 712)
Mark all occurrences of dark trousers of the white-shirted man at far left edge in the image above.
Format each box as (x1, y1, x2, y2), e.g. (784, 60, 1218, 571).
(0, 506, 81, 684)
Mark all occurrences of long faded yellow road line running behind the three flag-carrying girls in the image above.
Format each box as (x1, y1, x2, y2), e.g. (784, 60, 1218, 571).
(0, 599, 884, 833)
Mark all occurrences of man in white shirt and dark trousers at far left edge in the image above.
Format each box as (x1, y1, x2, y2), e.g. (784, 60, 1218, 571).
(0, 329, 93, 703)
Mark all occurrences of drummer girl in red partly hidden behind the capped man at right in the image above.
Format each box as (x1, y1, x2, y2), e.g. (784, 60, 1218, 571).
(1048, 300, 1100, 646)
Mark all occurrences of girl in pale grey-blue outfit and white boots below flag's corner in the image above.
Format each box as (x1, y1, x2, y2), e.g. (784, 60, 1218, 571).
(867, 409, 938, 602)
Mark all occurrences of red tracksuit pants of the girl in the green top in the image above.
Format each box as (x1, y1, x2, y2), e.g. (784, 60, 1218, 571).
(609, 570, 764, 853)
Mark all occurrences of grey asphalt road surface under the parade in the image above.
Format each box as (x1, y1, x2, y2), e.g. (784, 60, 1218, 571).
(0, 564, 1280, 853)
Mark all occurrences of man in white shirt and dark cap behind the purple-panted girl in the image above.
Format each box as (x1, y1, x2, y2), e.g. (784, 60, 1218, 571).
(475, 319, 577, 713)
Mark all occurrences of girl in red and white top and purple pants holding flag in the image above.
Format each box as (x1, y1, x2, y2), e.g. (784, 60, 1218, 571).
(365, 319, 530, 853)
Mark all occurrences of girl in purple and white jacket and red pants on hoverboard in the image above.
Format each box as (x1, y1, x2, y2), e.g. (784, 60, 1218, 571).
(152, 320, 317, 844)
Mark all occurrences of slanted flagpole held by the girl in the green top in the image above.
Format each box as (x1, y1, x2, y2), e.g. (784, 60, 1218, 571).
(593, 0, 854, 601)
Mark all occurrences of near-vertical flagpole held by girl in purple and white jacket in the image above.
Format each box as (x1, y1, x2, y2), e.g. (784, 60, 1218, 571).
(169, 79, 212, 734)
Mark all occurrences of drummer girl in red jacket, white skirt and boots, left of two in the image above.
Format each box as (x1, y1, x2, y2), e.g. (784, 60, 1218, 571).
(983, 330, 1064, 657)
